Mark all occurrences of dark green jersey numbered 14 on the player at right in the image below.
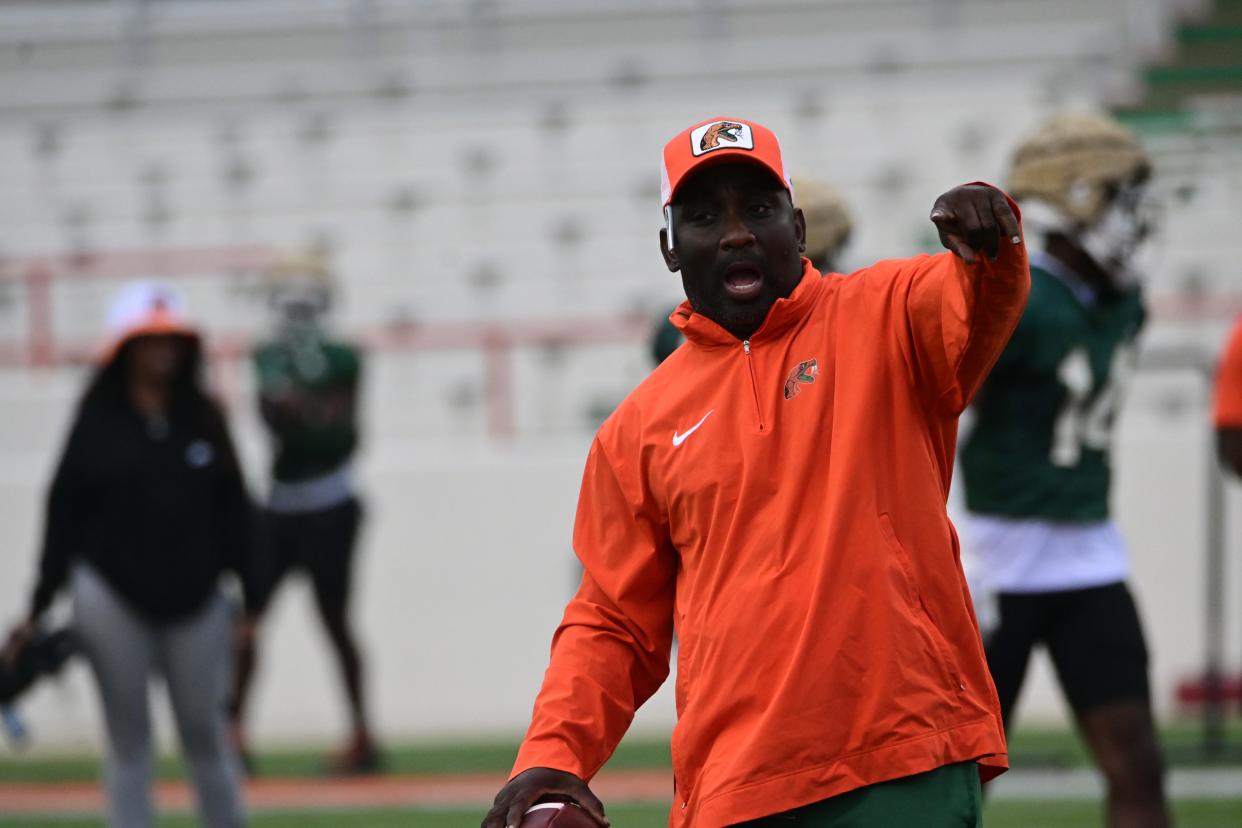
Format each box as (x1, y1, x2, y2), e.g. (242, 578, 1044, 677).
(961, 258, 1145, 521)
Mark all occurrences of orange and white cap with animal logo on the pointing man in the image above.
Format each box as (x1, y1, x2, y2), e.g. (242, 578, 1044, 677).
(660, 118, 794, 207)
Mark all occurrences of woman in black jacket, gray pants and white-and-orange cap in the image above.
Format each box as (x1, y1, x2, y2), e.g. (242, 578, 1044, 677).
(5, 283, 256, 828)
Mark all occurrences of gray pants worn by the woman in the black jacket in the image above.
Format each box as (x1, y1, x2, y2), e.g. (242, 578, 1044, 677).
(72, 565, 246, 828)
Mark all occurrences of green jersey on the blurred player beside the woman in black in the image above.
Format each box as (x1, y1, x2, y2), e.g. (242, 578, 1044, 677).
(253, 338, 361, 483)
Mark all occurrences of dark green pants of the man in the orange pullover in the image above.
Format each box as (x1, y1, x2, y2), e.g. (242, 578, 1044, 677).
(735, 762, 984, 828)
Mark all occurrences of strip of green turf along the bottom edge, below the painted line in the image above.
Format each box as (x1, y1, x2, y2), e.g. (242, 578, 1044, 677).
(0, 798, 1242, 828)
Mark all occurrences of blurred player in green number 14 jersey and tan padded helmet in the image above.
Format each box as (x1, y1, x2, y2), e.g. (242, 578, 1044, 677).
(961, 114, 1169, 827)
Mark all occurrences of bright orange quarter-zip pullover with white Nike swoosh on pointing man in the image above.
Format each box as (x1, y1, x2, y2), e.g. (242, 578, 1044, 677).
(513, 189, 1030, 828)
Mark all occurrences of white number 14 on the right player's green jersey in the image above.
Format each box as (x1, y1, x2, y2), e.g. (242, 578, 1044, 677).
(1048, 345, 1134, 468)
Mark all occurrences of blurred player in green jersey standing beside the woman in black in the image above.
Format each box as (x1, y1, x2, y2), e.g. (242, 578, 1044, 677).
(231, 256, 379, 773)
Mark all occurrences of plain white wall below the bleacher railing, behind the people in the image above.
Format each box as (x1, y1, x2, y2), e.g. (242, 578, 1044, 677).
(0, 342, 1242, 749)
